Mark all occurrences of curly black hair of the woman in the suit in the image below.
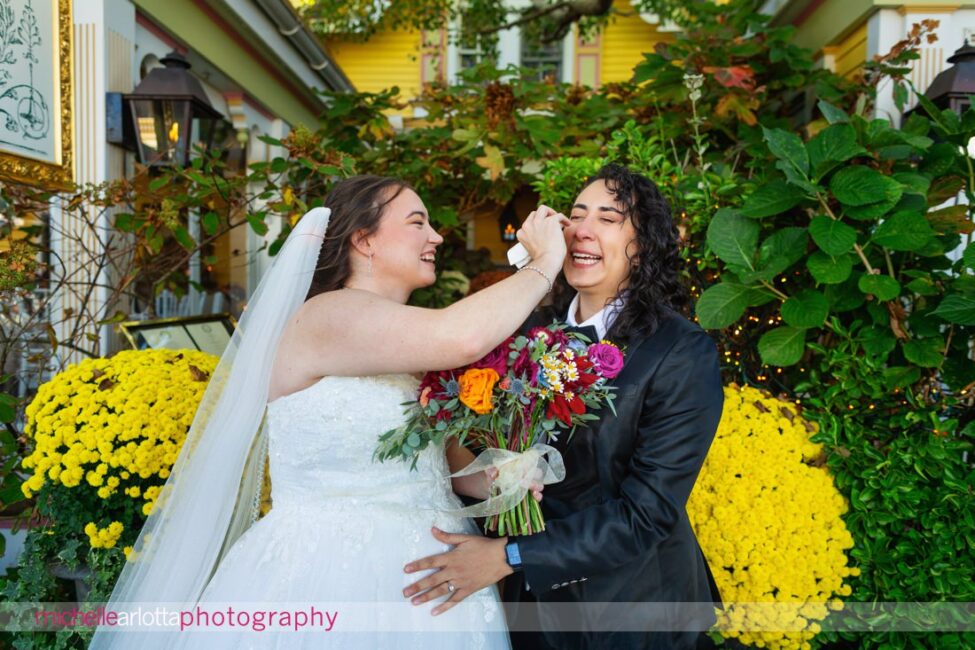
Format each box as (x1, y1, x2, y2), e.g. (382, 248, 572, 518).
(553, 163, 689, 340)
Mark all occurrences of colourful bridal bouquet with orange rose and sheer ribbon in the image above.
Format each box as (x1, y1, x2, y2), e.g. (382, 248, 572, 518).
(376, 324, 623, 535)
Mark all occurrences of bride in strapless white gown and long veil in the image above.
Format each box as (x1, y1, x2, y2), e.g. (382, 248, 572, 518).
(90, 177, 565, 650)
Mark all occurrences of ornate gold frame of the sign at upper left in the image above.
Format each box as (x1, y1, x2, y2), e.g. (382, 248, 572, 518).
(0, 0, 74, 190)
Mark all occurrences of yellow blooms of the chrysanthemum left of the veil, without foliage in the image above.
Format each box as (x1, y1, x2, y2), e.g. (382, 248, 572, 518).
(21, 350, 218, 548)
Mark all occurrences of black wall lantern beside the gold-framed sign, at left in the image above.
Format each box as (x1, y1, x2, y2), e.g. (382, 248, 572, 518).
(124, 52, 223, 167)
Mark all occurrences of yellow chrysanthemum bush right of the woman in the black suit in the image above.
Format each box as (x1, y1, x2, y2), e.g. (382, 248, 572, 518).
(687, 385, 859, 649)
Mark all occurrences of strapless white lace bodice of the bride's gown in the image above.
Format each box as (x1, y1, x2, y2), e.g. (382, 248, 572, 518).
(268, 375, 456, 510)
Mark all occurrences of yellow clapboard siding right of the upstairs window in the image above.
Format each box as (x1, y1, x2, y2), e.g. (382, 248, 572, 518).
(599, 2, 674, 83)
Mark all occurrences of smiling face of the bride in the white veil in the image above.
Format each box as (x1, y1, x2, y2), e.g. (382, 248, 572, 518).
(369, 189, 443, 292)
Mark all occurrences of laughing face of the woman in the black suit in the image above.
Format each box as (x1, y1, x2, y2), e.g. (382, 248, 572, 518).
(562, 180, 637, 305)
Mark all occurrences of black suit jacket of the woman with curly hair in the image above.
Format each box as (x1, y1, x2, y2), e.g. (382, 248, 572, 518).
(505, 310, 724, 648)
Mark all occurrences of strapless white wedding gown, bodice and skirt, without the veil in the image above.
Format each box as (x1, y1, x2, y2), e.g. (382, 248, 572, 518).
(178, 375, 510, 650)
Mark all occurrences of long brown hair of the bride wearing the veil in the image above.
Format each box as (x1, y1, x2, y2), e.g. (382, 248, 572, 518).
(305, 175, 413, 300)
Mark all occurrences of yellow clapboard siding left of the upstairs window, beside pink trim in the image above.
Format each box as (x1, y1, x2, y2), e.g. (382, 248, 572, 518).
(327, 31, 420, 98)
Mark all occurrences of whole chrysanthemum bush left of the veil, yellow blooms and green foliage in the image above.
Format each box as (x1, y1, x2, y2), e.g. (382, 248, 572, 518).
(10, 350, 218, 601)
